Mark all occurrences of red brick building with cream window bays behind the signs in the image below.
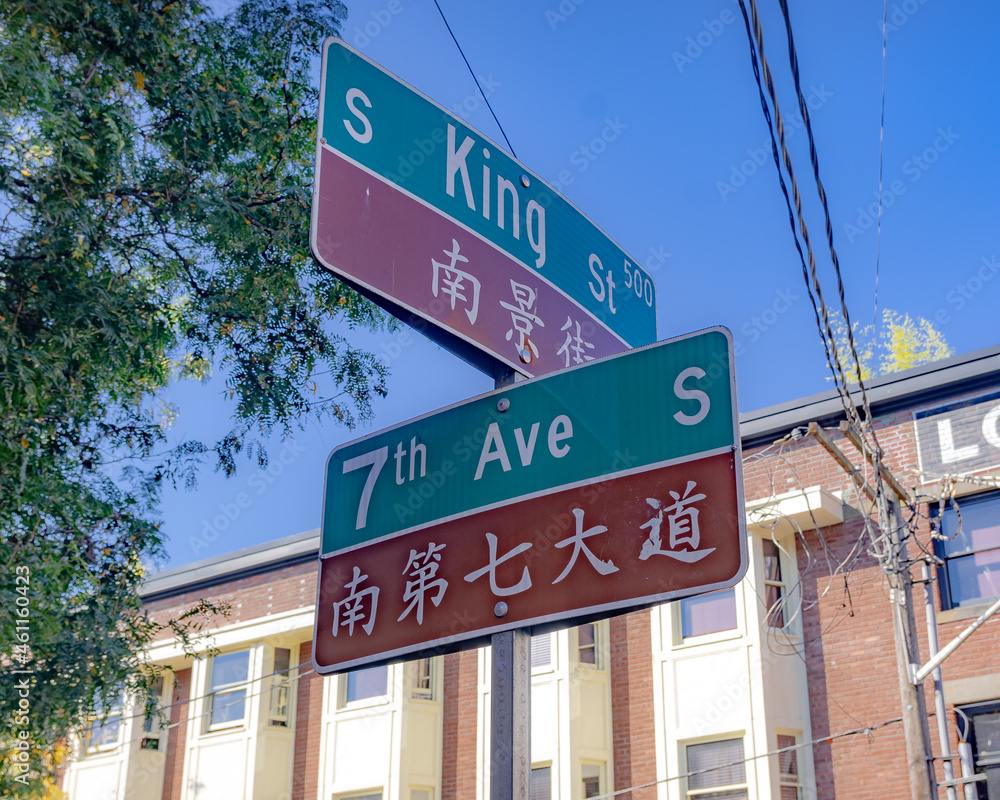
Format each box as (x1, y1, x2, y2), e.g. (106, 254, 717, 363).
(65, 347, 1000, 800)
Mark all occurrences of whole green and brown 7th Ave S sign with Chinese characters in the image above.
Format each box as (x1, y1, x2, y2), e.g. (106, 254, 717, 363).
(313, 328, 747, 673)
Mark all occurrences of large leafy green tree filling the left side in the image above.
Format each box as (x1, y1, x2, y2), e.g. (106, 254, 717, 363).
(0, 0, 386, 796)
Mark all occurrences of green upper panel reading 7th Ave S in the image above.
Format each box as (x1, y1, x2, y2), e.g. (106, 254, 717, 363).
(322, 328, 739, 555)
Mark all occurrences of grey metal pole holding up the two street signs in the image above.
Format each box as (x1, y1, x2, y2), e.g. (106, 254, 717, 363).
(490, 365, 531, 800)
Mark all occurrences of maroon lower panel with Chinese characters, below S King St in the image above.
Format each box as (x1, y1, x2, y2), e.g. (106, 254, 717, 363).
(313, 147, 626, 375)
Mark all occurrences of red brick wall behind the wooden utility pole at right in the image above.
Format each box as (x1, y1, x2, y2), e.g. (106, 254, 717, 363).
(744, 410, 1000, 798)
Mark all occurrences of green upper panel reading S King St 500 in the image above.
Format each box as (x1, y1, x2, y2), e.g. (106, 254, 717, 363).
(320, 39, 656, 347)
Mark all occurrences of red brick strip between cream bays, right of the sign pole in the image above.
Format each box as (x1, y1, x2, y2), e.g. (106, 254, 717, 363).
(609, 610, 657, 800)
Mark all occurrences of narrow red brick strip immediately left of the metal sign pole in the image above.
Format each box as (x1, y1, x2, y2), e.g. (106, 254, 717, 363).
(441, 650, 479, 800)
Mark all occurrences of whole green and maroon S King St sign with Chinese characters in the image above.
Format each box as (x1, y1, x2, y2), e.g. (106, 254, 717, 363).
(310, 39, 656, 376)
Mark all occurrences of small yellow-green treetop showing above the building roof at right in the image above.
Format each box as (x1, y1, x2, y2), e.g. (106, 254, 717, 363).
(831, 308, 952, 381)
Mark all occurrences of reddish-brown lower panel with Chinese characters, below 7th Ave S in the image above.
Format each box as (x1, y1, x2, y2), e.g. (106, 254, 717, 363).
(313, 453, 746, 673)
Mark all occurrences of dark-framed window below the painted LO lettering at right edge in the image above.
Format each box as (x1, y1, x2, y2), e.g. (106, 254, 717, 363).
(936, 494, 1000, 608)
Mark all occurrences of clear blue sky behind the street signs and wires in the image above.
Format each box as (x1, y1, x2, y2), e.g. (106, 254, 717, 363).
(150, 0, 1000, 567)
